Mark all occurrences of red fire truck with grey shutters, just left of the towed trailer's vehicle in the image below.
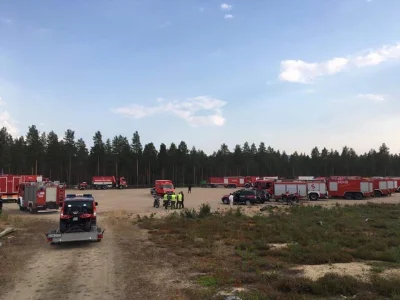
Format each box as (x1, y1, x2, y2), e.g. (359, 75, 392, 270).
(18, 182, 65, 213)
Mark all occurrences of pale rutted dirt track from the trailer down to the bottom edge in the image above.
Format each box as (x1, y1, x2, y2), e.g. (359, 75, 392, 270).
(3, 217, 123, 300)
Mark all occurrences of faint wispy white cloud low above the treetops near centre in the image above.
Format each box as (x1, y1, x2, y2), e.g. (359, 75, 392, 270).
(112, 96, 227, 127)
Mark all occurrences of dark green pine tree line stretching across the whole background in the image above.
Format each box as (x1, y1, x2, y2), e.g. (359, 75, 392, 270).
(0, 125, 400, 187)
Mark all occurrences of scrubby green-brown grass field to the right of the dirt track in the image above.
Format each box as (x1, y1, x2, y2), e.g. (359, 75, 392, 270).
(139, 203, 400, 299)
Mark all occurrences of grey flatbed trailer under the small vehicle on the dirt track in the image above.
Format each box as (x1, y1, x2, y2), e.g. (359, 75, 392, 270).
(45, 226, 106, 245)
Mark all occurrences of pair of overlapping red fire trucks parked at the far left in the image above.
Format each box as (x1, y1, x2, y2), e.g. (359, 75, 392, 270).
(0, 175, 66, 213)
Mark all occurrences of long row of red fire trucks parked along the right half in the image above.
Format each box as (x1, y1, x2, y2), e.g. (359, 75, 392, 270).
(202, 176, 400, 200)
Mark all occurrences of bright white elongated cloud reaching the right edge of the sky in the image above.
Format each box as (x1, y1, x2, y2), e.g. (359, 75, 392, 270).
(279, 43, 400, 83)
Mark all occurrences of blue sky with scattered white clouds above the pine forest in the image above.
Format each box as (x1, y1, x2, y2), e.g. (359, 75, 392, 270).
(0, 0, 400, 153)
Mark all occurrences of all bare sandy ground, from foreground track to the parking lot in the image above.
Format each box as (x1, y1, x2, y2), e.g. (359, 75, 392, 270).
(0, 188, 400, 300)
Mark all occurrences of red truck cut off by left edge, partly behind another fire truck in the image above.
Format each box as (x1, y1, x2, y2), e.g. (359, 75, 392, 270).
(0, 174, 43, 203)
